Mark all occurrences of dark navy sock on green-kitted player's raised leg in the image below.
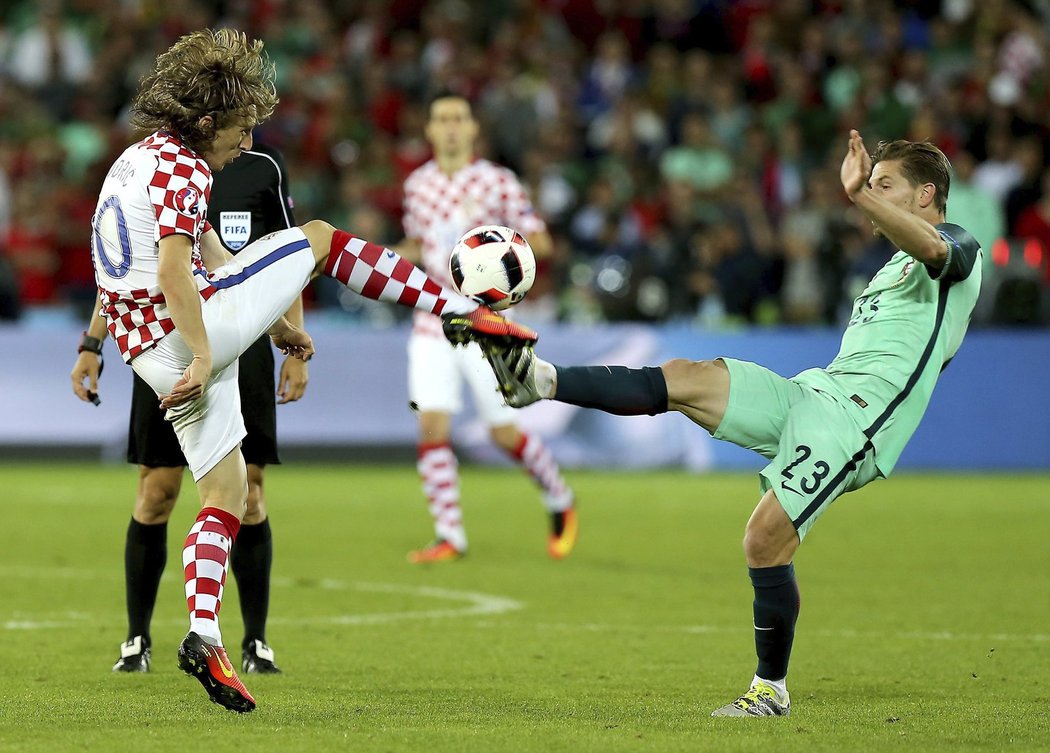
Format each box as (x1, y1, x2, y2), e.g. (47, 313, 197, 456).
(554, 367, 667, 416)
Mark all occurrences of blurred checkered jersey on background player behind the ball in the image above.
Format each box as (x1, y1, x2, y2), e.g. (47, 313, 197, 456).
(402, 160, 547, 337)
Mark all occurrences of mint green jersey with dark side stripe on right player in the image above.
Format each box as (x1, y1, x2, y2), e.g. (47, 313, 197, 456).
(794, 223, 981, 476)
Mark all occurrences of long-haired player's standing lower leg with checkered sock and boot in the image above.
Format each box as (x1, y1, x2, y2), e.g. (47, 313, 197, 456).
(179, 446, 255, 712)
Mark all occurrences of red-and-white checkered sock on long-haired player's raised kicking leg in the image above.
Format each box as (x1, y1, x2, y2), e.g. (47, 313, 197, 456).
(324, 225, 478, 315)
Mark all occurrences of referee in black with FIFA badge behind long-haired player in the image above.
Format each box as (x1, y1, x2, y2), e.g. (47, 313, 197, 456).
(71, 141, 308, 673)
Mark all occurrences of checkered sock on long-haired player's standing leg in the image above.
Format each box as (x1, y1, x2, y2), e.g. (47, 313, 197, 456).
(183, 507, 240, 646)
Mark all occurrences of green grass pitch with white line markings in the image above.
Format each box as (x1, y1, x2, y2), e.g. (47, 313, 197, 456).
(0, 463, 1050, 753)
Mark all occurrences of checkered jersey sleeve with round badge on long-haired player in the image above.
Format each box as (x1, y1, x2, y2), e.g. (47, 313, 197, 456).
(149, 154, 211, 239)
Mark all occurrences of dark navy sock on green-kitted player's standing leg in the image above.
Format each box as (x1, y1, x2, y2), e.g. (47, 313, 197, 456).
(748, 564, 799, 681)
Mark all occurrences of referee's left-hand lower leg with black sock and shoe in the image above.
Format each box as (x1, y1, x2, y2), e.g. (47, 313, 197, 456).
(113, 465, 184, 672)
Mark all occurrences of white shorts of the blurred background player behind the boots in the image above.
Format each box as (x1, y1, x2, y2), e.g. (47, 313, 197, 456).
(408, 333, 516, 426)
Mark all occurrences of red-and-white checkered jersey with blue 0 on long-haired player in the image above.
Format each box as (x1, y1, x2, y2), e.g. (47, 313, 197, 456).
(91, 131, 211, 361)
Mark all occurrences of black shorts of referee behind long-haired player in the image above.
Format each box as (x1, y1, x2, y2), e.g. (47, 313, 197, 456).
(128, 335, 280, 468)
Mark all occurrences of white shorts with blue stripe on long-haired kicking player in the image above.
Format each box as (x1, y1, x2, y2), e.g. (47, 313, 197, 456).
(131, 228, 316, 481)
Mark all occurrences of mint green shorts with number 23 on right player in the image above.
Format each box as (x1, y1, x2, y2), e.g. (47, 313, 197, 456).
(714, 358, 879, 540)
